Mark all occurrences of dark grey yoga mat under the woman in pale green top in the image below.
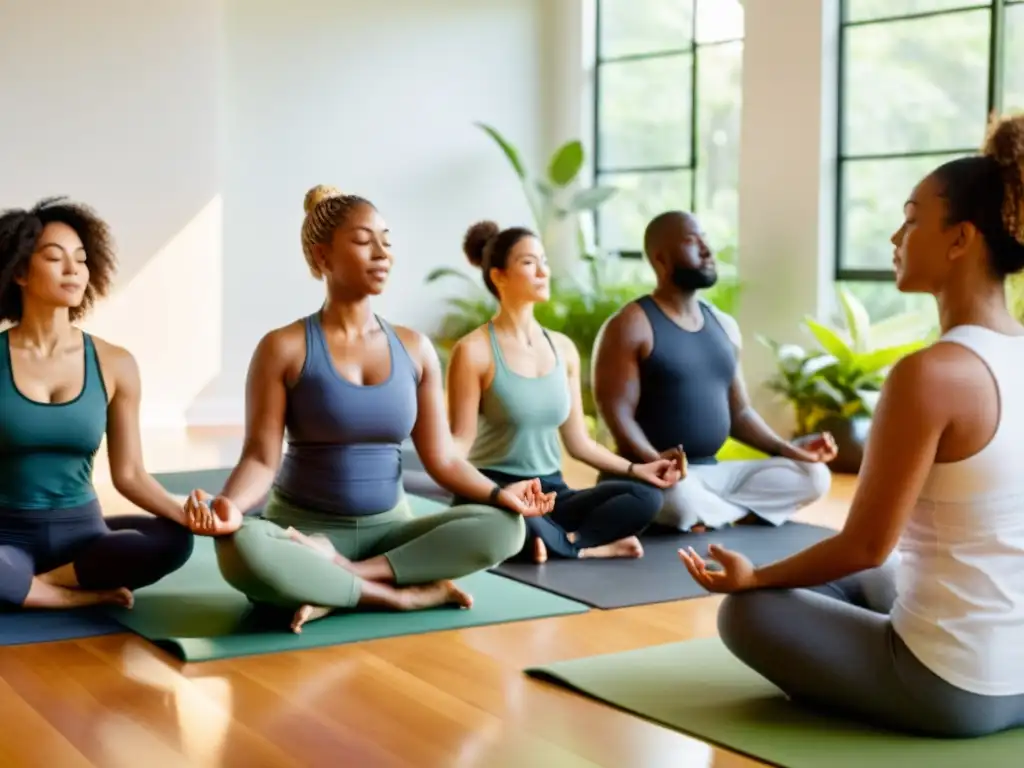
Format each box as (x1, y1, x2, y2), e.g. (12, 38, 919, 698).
(493, 522, 836, 608)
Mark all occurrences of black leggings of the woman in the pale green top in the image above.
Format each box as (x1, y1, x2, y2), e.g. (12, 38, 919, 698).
(454, 469, 662, 558)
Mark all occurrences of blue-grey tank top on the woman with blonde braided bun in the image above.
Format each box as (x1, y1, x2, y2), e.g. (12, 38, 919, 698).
(274, 312, 419, 516)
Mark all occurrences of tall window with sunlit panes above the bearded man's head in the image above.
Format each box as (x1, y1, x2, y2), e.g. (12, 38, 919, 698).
(594, 0, 743, 256)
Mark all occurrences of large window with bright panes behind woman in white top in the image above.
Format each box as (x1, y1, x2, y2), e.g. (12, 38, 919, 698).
(836, 0, 1024, 315)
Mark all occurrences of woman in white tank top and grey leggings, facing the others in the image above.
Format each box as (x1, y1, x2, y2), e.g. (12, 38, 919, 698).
(680, 116, 1024, 736)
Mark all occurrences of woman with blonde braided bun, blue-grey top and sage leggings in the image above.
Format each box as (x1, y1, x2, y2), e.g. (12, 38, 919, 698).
(186, 186, 551, 632)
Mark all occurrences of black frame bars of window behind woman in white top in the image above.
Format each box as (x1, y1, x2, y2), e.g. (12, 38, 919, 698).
(834, 0, 1024, 283)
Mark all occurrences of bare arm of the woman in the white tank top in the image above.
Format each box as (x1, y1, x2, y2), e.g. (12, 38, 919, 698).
(755, 349, 963, 589)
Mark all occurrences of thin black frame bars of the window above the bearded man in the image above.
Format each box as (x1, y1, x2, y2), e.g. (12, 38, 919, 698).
(591, 0, 746, 259)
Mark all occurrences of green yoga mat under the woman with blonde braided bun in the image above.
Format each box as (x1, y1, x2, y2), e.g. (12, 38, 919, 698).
(109, 532, 587, 662)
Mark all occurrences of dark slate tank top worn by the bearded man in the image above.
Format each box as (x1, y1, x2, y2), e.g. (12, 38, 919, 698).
(636, 296, 737, 464)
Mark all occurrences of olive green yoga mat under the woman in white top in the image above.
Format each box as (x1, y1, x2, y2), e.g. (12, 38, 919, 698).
(526, 639, 1024, 768)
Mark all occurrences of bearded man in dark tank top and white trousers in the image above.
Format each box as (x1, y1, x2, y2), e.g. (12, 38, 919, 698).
(593, 211, 836, 530)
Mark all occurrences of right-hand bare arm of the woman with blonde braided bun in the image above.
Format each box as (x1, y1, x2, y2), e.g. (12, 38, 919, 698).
(403, 328, 521, 509)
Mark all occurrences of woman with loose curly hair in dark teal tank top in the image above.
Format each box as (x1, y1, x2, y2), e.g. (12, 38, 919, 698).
(0, 198, 193, 611)
